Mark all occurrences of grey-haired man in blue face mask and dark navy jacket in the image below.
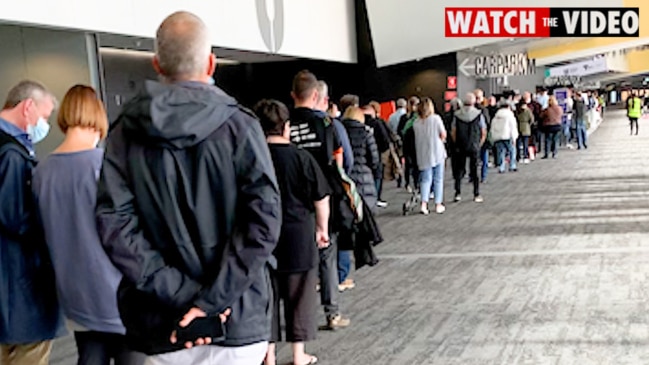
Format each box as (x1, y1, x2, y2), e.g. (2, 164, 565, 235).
(0, 81, 64, 365)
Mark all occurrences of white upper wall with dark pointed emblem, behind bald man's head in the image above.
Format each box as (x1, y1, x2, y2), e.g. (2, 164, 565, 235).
(0, 0, 357, 63)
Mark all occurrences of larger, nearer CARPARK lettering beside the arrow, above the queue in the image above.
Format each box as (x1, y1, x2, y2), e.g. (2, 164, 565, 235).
(475, 53, 536, 77)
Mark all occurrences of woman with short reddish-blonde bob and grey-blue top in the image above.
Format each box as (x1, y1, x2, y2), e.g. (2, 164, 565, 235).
(33, 85, 144, 365)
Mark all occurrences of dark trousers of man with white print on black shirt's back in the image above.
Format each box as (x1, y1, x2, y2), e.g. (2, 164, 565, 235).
(319, 233, 340, 318)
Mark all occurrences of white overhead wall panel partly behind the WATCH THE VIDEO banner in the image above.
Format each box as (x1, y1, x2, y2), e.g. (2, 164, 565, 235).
(366, 0, 622, 67)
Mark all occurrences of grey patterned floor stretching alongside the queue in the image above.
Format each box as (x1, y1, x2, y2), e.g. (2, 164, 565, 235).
(53, 112, 649, 365)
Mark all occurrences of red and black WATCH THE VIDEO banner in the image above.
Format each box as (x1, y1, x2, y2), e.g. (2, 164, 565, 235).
(445, 7, 640, 38)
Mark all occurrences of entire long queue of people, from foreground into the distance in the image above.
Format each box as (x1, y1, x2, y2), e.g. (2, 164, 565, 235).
(0, 12, 612, 365)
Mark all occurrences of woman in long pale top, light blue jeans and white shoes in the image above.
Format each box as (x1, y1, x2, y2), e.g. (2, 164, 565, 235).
(412, 98, 446, 215)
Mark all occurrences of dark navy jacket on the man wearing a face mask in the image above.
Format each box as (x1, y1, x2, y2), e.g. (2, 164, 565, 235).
(0, 131, 65, 344)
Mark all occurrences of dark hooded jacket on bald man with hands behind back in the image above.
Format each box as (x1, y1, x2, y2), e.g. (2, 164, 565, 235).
(97, 82, 281, 354)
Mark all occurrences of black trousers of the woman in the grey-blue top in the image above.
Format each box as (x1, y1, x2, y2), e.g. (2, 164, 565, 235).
(74, 331, 146, 365)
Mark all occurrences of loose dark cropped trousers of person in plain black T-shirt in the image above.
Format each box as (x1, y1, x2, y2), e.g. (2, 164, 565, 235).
(271, 268, 318, 342)
